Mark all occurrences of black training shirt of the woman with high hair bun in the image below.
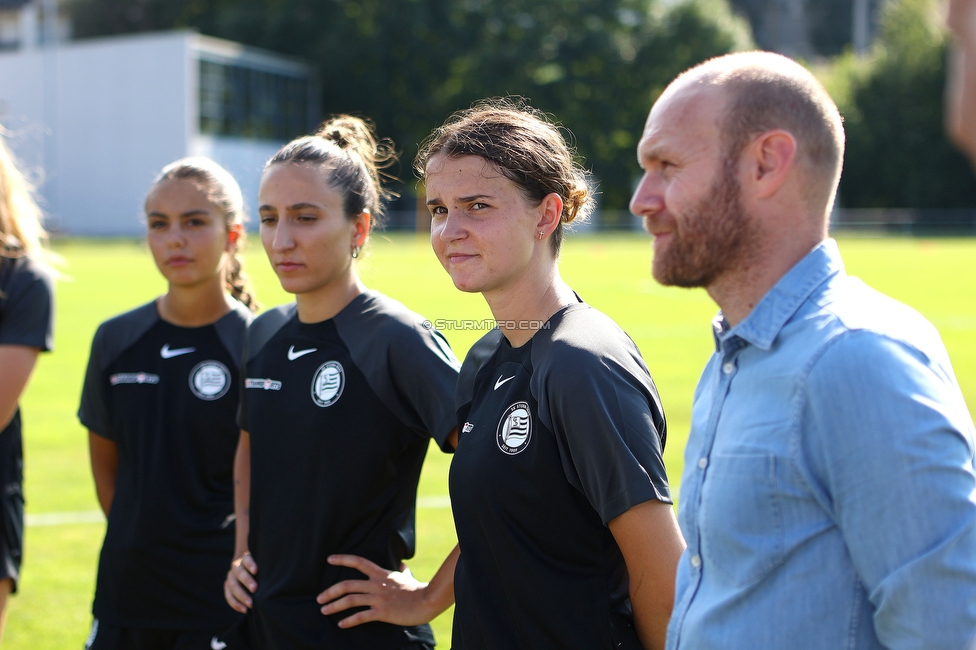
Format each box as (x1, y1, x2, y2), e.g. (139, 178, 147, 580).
(239, 292, 458, 650)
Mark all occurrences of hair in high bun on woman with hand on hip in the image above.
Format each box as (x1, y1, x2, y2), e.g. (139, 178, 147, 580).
(264, 115, 397, 227)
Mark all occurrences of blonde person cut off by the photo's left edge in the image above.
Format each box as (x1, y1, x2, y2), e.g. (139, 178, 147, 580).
(0, 129, 54, 637)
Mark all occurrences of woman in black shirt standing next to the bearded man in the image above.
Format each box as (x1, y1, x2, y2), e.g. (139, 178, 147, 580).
(415, 100, 684, 650)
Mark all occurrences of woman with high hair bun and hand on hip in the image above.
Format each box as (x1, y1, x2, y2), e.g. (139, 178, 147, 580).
(225, 116, 458, 650)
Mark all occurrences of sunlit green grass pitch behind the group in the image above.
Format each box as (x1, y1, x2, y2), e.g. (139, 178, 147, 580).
(4, 233, 976, 650)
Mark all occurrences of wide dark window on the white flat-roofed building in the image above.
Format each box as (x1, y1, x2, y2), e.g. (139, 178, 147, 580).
(200, 60, 309, 140)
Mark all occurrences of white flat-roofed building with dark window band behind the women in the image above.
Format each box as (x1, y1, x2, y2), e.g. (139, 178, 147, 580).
(0, 28, 319, 235)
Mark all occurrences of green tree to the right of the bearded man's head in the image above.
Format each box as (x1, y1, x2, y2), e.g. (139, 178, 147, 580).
(828, 0, 976, 208)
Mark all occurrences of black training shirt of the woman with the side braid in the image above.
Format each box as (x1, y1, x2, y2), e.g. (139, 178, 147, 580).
(78, 302, 251, 630)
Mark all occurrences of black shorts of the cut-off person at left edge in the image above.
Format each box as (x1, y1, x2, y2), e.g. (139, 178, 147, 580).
(0, 420, 24, 593)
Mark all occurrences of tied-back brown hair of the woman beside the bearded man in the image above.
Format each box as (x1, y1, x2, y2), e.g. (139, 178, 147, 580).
(414, 98, 595, 257)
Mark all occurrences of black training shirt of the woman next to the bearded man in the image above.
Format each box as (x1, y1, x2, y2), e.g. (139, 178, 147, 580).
(450, 303, 671, 650)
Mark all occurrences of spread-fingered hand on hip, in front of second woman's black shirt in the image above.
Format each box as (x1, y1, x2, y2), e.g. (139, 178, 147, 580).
(316, 555, 434, 628)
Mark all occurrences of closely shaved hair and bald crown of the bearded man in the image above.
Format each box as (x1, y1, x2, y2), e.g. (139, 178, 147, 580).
(662, 52, 844, 216)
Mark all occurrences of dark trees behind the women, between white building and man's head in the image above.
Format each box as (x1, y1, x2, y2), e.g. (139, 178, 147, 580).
(73, 0, 751, 209)
